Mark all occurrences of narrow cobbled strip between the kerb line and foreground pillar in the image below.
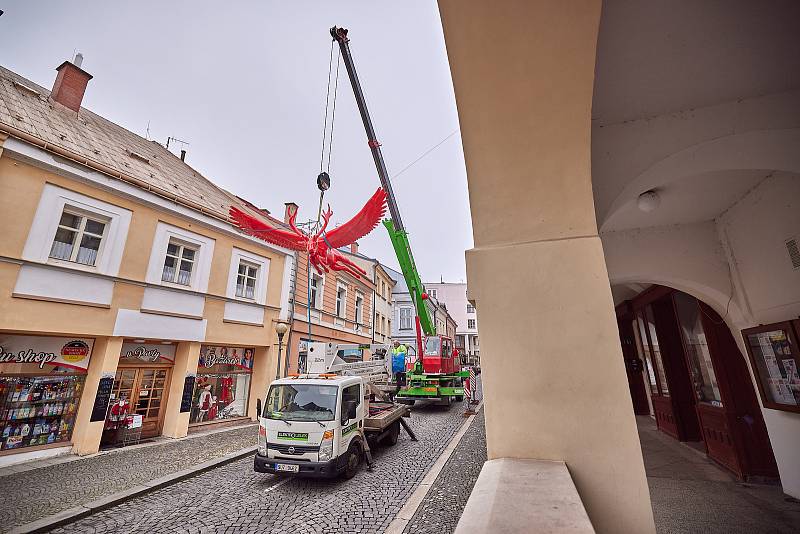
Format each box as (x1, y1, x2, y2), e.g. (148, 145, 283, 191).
(404, 410, 486, 534)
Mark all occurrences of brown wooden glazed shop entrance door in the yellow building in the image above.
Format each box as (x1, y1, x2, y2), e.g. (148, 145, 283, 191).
(113, 367, 169, 438)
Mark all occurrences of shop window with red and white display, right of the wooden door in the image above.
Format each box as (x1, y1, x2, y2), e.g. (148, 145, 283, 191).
(190, 345, 255, 424)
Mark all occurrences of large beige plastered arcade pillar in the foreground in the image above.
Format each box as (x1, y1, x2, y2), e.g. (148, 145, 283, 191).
(439, 0, 655, 533)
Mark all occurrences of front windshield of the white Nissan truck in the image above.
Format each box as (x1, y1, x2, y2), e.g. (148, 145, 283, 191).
(264, 384, 339, 421)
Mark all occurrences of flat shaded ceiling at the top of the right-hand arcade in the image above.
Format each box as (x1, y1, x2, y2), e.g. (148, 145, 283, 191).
(592, 0, 800, 126)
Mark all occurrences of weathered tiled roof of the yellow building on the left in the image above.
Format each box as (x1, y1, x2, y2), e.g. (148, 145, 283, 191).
(0, 63, 278, 224)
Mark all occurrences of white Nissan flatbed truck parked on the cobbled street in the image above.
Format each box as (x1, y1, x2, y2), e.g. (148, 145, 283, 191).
(253, 343, 416, 478)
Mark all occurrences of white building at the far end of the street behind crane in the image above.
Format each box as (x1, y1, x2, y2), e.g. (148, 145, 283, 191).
(425, 282, 481, 365)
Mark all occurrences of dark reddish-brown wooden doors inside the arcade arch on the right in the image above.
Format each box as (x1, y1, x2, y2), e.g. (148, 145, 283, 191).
(617, 285, 778, 480)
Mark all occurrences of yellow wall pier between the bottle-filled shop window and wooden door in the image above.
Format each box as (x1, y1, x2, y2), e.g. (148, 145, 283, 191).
(72, 337, 122, 455)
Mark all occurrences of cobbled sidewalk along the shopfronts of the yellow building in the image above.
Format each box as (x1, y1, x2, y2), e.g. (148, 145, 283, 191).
(0, 425, 257, 529)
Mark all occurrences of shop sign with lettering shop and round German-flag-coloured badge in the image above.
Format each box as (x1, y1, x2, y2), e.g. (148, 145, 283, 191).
(0, 334, 94, 371)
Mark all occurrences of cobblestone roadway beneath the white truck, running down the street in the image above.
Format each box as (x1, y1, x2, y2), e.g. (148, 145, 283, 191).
(54, 405, 472, 534)
